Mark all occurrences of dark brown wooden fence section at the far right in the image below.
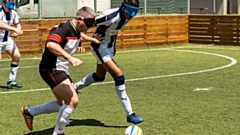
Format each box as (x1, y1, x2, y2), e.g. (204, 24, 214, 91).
(189, 15, 240, 45)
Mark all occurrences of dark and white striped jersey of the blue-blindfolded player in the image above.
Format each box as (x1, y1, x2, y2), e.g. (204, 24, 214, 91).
(91, 7, 128, 48)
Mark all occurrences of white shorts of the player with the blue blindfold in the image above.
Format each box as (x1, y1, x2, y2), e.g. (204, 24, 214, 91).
(91, 45, 114, 64)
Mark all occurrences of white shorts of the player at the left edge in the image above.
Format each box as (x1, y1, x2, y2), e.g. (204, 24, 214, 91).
(0, 37, 17, 52)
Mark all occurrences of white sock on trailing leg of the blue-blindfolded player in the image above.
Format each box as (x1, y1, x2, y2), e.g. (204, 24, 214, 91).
(74, 73, 96, 90)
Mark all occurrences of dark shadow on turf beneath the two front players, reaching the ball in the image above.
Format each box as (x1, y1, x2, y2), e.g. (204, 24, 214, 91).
(24, 119, 128, 135)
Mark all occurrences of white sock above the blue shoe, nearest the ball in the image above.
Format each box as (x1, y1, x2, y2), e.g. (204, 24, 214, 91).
(115, 84, 133, 116)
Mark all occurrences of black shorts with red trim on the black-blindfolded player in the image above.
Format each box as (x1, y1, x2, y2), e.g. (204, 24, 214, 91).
(39, 69, 72, 89)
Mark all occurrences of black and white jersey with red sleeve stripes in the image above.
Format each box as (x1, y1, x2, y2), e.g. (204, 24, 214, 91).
(40, 21, 81, 74)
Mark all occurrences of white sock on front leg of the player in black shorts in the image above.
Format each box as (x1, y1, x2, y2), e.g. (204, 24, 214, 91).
(53, 104, 74, 135)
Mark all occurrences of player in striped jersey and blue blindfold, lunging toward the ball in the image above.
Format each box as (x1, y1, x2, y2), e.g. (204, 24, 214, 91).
(74, 0, 143, 124)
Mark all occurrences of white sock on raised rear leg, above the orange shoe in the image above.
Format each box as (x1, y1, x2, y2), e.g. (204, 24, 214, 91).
(29, 100, 61, 116)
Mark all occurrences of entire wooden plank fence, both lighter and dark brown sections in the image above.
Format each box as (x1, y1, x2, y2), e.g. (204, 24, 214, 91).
(3, 15, 240, 56)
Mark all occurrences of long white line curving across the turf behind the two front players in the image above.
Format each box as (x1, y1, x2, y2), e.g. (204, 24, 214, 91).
(0, 50, 237, 94)
